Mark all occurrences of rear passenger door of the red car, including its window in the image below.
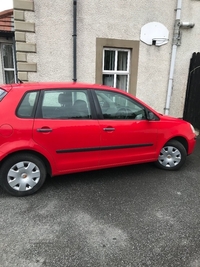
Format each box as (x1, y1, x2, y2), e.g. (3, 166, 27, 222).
(33, 89, 100, 173)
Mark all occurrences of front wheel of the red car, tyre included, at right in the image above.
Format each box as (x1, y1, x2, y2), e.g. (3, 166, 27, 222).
(156, 140, 187, 170)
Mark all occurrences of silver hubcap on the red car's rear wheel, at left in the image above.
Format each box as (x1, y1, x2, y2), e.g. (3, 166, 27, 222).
(7, 161, 40, 191)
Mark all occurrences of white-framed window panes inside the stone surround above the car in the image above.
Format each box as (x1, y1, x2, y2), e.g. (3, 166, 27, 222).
(103, 48, 130, 92)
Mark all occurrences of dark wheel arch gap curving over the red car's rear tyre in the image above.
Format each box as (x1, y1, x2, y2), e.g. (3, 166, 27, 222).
(0, 149, 52, 176)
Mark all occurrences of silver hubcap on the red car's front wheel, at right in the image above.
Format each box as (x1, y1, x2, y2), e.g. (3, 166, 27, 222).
(158, 146, 181, 168)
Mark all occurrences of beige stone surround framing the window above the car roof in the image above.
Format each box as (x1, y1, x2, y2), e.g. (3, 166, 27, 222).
(95, 38, 140, 95)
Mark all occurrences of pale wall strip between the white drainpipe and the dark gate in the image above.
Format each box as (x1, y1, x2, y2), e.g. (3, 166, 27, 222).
(170, 0, 200, 116)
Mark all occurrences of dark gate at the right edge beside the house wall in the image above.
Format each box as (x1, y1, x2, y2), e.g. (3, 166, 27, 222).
(183, 53, 200, 129)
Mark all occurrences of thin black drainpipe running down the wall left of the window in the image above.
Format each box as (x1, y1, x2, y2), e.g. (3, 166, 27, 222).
(72, 0, 77, 82)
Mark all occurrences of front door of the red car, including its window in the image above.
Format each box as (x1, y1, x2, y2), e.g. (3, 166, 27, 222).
(95, 90, 158, 166)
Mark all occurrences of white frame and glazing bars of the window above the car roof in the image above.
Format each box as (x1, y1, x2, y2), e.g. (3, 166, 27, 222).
(102, 47, 131, 92)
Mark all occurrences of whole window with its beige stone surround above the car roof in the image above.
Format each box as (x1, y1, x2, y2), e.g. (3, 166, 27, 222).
(95, 38, 140, 95)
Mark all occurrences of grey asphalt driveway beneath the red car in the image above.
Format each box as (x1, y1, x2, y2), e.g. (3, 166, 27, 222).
(0, 138, 200, 267)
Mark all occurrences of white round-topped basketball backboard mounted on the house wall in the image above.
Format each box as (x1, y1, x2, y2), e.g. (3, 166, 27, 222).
(140, 22, 169, 46)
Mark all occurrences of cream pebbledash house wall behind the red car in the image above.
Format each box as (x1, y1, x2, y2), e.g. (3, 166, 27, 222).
(14, 0, 200, 116)
